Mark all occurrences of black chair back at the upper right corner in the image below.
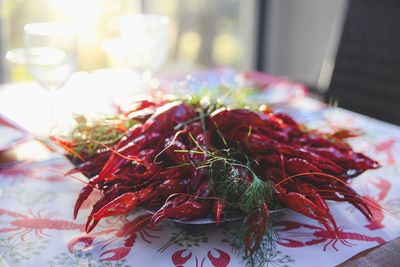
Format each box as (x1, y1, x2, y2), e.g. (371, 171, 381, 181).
(326, 0, 400, 125)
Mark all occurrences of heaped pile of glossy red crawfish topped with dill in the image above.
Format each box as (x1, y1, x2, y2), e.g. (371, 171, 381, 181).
(54, 97, 379, 254)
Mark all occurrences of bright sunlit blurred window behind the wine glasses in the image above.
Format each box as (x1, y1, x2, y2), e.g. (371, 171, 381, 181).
(0, 0, 257, 81)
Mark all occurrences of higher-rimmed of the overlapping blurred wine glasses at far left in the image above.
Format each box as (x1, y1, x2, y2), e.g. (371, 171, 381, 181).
(24, 22, 76, 134)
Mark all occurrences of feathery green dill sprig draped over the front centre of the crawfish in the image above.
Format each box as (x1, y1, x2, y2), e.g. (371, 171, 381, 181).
(174, 133, 278, 214)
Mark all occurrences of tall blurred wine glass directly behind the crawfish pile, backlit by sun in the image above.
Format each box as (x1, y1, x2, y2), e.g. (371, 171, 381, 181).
(119, 14, 169, 93)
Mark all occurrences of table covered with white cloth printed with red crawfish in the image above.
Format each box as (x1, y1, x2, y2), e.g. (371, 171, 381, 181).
(0, 71, 400, 267)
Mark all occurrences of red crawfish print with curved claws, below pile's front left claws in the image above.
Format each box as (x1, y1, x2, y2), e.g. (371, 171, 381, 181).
(67, 215, 161, 261)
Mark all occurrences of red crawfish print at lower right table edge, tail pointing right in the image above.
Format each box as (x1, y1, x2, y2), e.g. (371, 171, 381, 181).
(276, 221, 385, 251)
